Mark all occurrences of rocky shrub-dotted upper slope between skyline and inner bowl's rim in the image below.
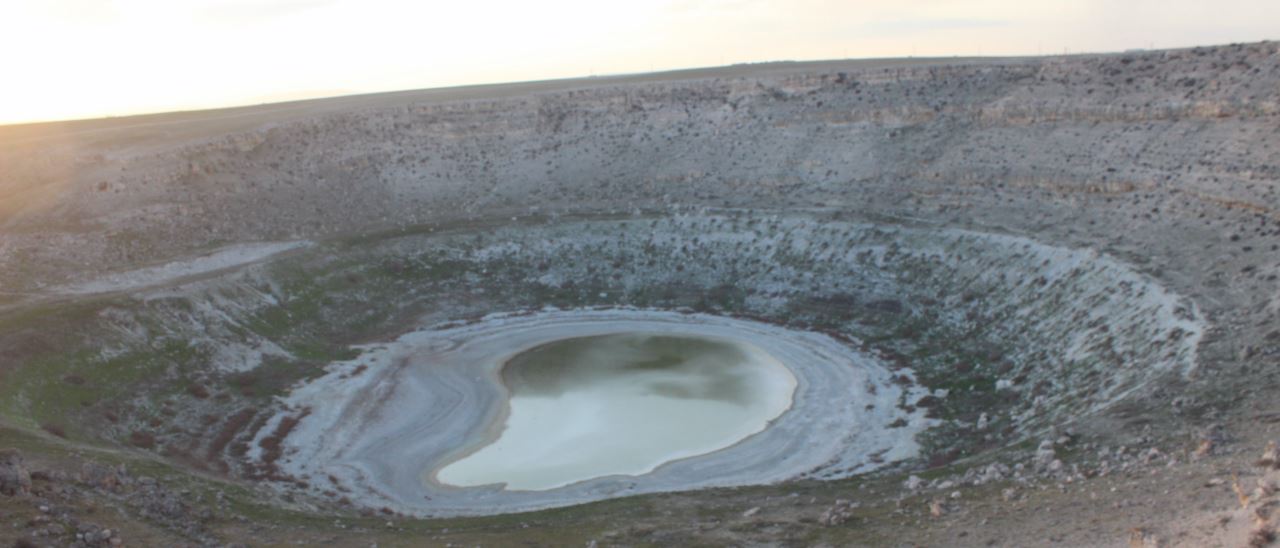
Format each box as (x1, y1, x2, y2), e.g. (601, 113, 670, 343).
(0, 42, 1280, 299)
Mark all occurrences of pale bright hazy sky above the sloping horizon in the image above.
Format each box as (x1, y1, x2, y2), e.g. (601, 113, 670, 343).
(0, 0, 1280, 124)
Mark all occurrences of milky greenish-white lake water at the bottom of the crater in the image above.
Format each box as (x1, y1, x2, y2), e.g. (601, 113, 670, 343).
(436, 333, 796, 490)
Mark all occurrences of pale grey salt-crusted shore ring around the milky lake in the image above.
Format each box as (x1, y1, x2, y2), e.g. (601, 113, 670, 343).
(272, 309, 929, 516)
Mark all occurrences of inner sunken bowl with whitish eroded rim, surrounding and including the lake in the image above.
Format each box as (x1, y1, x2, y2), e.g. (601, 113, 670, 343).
(3, 211, 1204, 516)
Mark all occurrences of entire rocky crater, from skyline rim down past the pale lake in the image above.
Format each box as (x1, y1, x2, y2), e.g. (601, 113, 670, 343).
(0, 44, 1280, 545)
